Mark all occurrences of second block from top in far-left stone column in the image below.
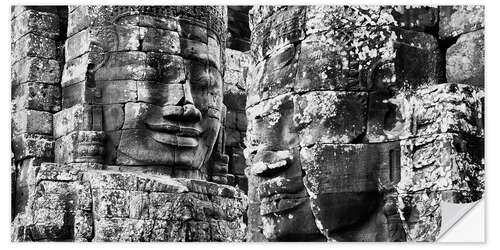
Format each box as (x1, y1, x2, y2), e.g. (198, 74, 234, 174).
(11, 33, 56, 63)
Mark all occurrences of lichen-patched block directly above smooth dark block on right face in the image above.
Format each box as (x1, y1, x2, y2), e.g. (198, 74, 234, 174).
(293, 91, 367, 146)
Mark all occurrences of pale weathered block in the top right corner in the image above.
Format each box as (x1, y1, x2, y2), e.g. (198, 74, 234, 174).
(439, 5, 484, 38)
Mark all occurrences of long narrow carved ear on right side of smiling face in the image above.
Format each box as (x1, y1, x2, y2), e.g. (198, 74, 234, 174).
(208, 104, 234, 184)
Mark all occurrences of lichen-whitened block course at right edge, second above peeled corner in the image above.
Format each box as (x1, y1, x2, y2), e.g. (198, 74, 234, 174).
(367, 83, 484, 142)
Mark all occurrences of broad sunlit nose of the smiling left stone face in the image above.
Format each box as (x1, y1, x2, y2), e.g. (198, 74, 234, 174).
(162, 81, 201, 122)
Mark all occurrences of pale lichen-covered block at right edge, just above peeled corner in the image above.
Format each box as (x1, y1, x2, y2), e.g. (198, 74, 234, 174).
(398, 133, 484, 202)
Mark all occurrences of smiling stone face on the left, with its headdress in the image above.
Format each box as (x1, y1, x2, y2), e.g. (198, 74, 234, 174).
(85, 8, 223, 176)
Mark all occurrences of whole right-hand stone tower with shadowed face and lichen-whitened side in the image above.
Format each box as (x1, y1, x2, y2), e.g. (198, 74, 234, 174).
(245, 6, 484, 241)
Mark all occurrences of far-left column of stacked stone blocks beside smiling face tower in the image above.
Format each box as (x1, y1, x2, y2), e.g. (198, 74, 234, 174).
(11, 6, 65, 221)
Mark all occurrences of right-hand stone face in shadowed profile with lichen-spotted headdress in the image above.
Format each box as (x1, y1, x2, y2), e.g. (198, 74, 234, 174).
(247, 6, 402, 240)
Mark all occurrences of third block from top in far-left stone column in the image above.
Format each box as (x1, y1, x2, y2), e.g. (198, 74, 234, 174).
(11, 57, 61, 85)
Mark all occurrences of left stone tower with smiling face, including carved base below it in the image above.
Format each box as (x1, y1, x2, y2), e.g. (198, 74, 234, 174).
(13, 6, 246, 241)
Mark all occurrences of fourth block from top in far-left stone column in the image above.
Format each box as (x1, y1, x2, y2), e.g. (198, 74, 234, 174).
(12, 82, 61, 113)
